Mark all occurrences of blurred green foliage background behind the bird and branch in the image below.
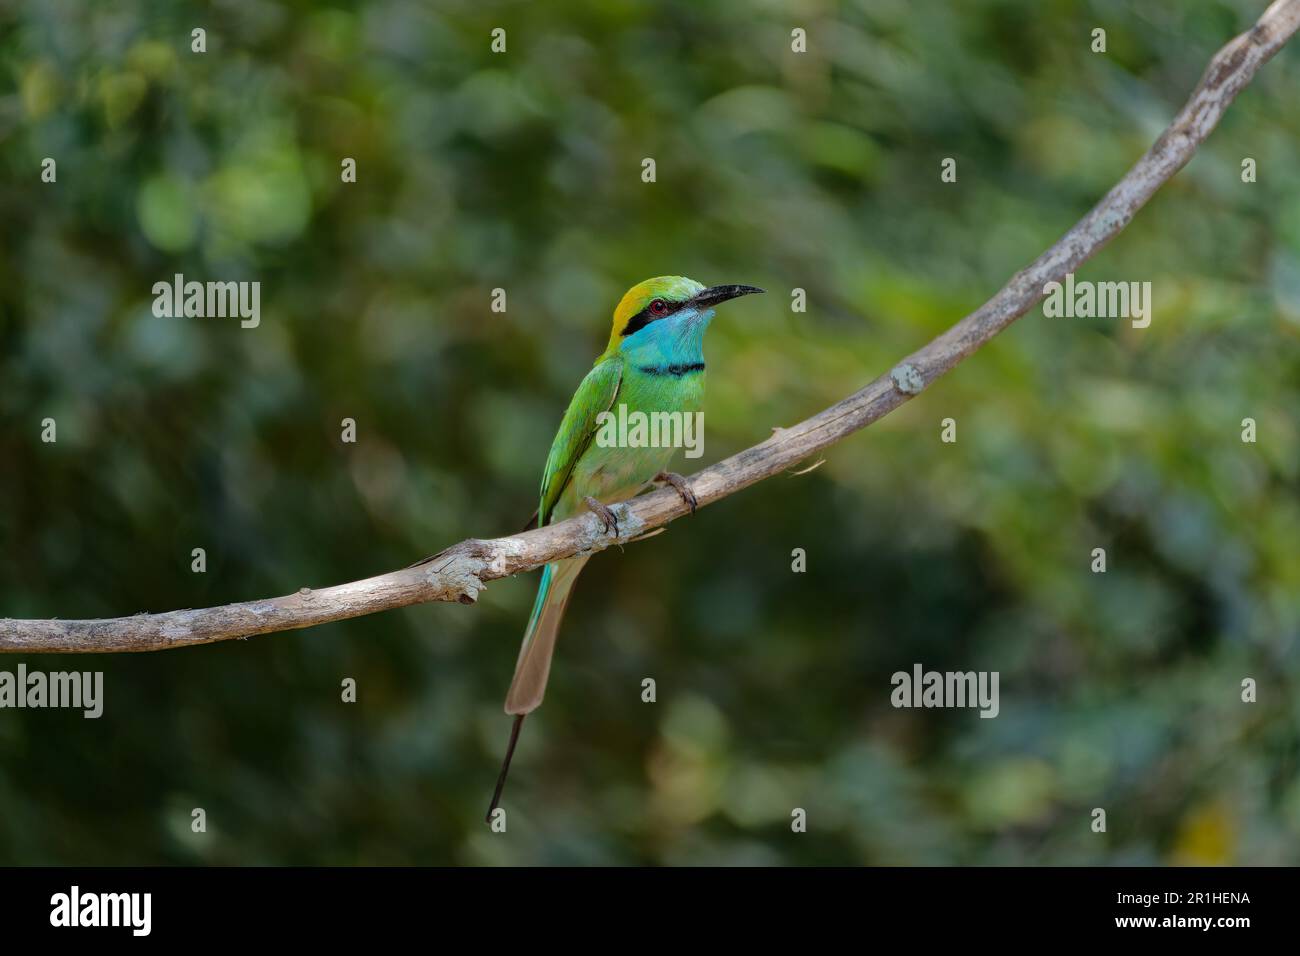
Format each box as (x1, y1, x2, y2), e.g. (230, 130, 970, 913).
(0, 0, 1300, 864)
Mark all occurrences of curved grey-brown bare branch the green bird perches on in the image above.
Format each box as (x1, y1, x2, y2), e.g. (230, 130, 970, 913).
(0, 0, 1300, 653)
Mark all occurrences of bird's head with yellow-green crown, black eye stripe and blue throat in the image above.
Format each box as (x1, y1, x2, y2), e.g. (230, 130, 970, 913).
(607, 276, 763, 355)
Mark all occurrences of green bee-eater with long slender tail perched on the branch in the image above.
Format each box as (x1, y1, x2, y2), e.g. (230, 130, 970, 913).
(488, 276, 763, 819)
